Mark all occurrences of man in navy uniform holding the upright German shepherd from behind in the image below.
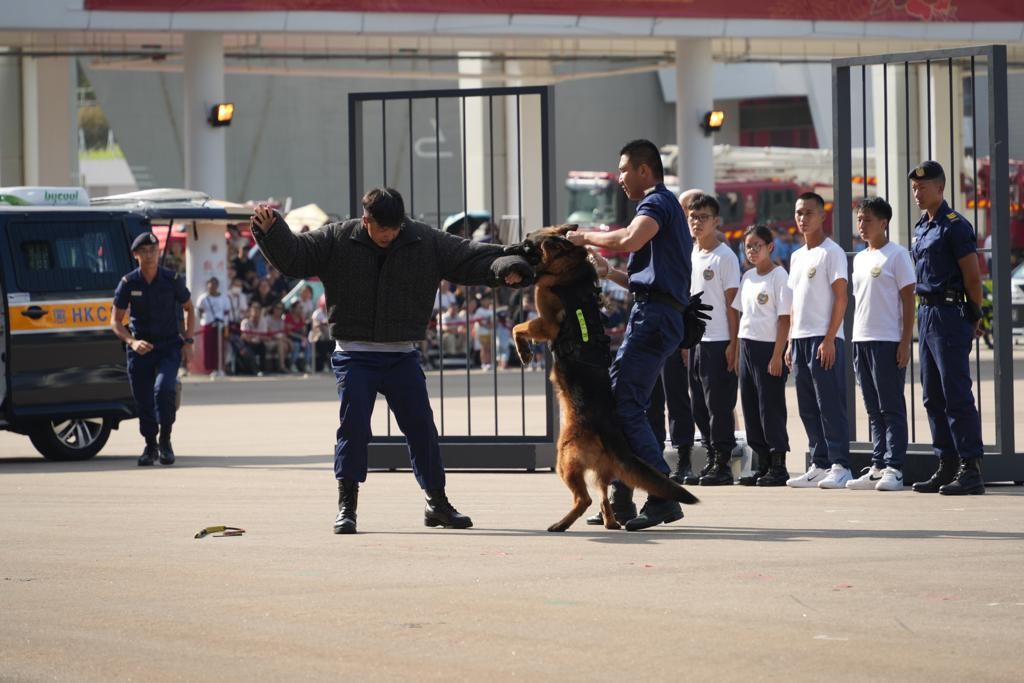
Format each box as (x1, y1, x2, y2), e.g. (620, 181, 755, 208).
(565, 139, 693, 531)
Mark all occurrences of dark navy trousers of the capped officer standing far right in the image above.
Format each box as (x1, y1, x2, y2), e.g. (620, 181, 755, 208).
(918, 304, 983, 459)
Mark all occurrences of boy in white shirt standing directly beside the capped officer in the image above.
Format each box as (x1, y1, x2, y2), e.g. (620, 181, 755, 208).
(846, 197, 918, 490)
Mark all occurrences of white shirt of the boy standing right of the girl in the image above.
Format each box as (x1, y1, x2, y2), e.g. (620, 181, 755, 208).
(790, 238, 849, 339)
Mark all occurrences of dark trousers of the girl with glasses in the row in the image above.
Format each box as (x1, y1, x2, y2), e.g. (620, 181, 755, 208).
(739, 339, 790, 463)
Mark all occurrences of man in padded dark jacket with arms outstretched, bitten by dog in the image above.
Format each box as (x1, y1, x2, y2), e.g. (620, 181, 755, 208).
(252, 188, 532, 533)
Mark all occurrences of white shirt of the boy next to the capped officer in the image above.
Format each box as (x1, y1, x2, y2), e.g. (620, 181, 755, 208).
(853, 242, 918, 342)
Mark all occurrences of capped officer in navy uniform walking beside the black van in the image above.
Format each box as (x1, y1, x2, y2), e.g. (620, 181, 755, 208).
(111, 232, 196, 466)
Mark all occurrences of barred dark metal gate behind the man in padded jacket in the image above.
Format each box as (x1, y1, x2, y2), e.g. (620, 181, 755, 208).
(348, 87, 557, 470)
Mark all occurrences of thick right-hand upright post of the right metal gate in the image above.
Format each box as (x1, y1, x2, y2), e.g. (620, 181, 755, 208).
(987, 45, 1016, 455)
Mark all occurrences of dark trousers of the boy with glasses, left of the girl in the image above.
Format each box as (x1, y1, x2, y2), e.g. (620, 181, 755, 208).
(689, 341, 739, 453)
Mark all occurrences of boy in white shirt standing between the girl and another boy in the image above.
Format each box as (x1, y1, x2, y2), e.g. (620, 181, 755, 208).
(785, 193, 851, 488)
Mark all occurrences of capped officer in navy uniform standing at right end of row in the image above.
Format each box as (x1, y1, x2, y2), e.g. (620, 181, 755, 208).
(908, 161, 985, 496)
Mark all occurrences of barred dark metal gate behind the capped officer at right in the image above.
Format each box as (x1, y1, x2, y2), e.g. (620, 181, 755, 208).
(831, 45, 1024, 482)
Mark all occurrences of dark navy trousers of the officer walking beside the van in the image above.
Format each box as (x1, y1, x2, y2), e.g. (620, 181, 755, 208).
(128, 339, 181, 439)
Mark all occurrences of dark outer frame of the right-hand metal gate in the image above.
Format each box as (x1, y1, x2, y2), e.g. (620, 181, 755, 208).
(831, 45, 1024, 483)
